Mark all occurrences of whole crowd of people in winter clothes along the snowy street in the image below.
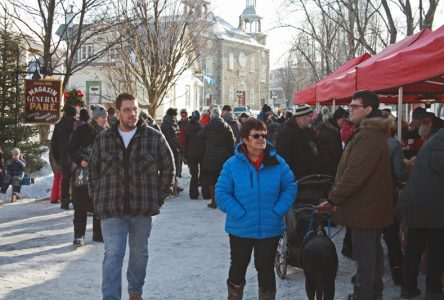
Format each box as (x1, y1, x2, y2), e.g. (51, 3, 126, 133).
(0, 90, 444, 300)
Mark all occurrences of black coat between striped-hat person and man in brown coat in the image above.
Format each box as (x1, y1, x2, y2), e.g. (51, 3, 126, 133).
(318, 119, 342, 177)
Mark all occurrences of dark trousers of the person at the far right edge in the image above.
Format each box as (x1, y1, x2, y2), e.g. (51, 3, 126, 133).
(402, 228, 444, 293)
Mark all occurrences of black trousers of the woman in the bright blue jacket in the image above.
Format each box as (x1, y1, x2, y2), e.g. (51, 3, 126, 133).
(228, 234, 279, 291)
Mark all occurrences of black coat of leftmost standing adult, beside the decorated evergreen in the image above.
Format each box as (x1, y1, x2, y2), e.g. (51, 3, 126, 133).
(51, 115, 75, 168)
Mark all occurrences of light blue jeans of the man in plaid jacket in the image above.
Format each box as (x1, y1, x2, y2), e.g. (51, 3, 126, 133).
(101, 216, 151, 300)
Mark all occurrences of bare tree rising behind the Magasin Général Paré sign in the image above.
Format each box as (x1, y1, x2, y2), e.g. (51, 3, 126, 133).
(2, 0, 122, 89)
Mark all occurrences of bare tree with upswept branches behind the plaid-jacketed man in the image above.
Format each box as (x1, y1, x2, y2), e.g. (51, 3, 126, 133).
(111, 0, 200, 115)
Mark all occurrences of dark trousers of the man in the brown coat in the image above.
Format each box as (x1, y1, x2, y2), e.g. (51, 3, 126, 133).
(351, 229, 384, 300)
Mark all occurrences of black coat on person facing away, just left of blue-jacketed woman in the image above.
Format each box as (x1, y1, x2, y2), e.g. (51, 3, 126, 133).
(199, 118, 235, 171)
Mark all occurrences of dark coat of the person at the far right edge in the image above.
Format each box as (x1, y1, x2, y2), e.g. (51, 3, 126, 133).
(396, 129, 444, 228)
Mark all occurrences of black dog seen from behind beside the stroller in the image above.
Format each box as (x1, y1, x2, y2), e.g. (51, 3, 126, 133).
(301, 218, 338, 300)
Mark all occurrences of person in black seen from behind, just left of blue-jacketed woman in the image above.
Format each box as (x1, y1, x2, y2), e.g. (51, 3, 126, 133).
(199, 106, 235, 208)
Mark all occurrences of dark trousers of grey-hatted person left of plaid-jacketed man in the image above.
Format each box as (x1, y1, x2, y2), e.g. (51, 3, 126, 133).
(73, 185, 102, 238)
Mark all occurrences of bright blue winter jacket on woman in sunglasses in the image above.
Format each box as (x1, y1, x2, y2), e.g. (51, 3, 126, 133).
(216, 143, 297, 239)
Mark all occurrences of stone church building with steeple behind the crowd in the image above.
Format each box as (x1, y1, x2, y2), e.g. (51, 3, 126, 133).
(182, 0, 270, 110)
